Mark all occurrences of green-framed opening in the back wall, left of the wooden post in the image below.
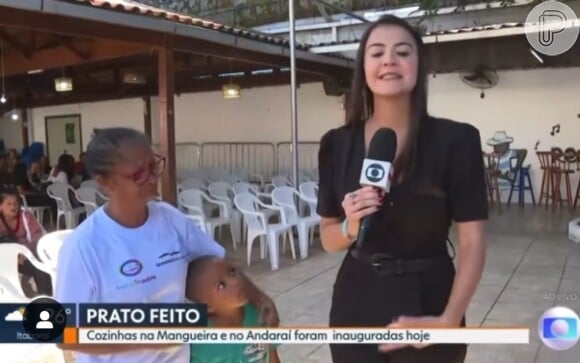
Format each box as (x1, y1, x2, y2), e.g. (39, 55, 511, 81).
(44, 114, 83, 166)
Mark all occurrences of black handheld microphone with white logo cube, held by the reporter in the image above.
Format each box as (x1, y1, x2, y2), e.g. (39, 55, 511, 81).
(357, 128, 397, 247)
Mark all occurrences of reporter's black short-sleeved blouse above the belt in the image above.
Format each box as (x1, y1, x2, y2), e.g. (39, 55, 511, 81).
(317, 117, 488, 258)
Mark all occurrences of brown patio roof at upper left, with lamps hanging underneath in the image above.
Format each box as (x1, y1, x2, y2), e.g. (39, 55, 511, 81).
(0, 0, 352, 106)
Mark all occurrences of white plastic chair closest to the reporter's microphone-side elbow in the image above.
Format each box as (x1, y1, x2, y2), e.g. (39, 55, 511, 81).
(272, 187, 320, 259)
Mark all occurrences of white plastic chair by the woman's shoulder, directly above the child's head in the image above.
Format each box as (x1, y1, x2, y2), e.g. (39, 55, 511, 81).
(179, 189, 237, 249)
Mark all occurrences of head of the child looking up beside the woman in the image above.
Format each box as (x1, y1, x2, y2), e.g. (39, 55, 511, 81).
(185, 256, 248, 313)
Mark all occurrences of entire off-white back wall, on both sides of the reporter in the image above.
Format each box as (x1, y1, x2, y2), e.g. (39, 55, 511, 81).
(11, 68, 580, 205)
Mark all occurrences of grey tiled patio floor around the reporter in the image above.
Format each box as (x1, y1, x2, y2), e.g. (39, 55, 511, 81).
(62, 206, 580, 363)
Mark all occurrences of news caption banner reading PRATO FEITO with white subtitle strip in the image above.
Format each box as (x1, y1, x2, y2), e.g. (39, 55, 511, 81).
(0, 298, 544, 344)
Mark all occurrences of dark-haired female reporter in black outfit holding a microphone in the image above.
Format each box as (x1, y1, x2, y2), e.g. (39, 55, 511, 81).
(318, 16, 488, 363)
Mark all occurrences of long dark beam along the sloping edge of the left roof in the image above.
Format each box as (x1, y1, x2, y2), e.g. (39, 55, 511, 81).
(0, 2, 347, 76)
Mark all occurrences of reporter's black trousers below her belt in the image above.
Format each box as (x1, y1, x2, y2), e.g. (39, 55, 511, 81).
(329, 255, 467, 363)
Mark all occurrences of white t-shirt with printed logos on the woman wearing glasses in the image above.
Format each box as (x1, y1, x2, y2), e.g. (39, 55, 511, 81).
(55, 202, 225, 363)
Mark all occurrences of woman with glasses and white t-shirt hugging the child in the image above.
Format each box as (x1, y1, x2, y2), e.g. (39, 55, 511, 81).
(55, 128, 278, 363)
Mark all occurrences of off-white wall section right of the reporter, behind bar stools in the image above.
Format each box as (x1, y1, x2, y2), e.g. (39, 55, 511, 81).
(429, 68, 580, 205)
